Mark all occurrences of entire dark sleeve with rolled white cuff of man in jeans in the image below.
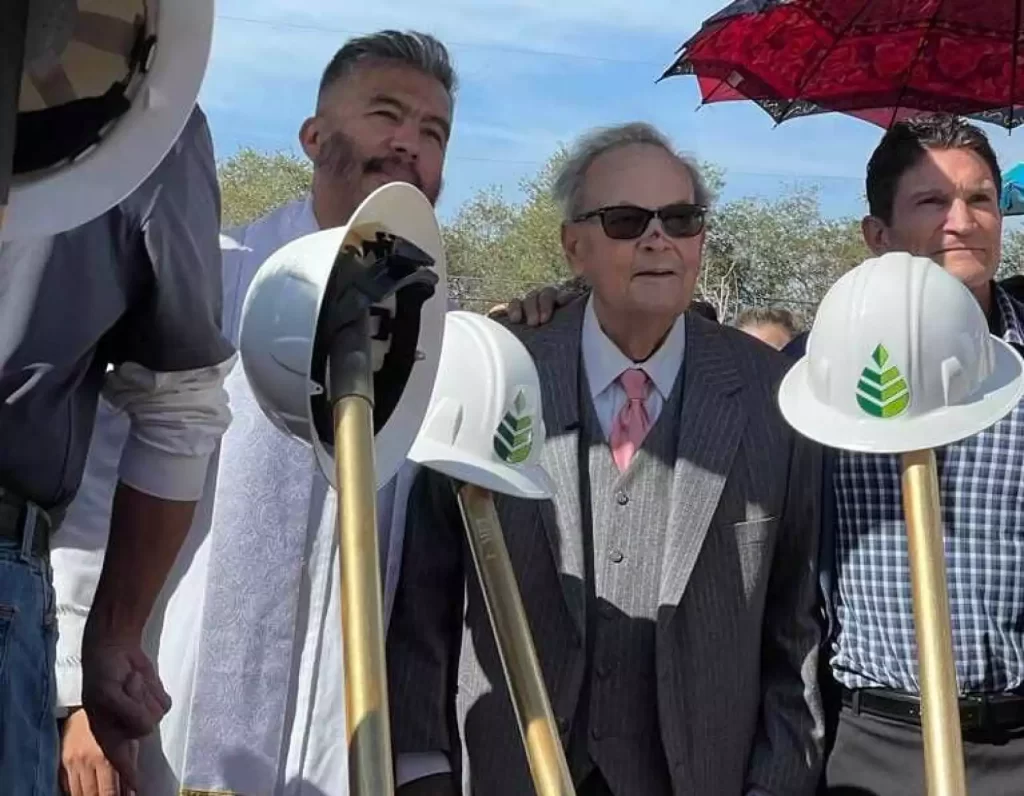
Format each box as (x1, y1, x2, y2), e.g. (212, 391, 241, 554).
(92, 108, 236, 501)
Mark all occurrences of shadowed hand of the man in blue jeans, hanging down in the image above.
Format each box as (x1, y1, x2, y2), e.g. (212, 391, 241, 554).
(82, 633, 171, 792)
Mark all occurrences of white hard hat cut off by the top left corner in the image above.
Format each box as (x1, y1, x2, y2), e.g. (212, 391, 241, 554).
(0, 0, 214, 241)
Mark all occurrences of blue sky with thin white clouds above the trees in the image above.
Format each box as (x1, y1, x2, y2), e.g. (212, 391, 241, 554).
(200, 0, 1024, 223)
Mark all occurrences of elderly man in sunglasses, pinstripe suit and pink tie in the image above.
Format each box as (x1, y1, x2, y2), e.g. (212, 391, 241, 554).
(388, 119, 821, 796)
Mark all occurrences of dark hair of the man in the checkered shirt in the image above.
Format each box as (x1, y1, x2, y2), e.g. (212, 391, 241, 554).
(866, 116, 1002, 224)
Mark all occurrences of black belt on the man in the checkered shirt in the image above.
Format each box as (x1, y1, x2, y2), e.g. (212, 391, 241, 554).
(843, 688, 1024, 731)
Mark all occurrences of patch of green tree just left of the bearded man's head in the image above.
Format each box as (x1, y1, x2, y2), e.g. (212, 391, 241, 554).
(217, 148, 313, 227)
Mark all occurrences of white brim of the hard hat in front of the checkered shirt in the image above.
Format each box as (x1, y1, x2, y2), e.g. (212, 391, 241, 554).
(778, 336, 1024, 454)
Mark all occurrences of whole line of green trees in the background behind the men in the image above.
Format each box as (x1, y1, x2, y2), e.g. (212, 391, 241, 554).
(211, 148, 1024, 313)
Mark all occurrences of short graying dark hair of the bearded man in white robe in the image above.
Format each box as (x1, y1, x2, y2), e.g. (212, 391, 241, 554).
(317, 31, 459, 104)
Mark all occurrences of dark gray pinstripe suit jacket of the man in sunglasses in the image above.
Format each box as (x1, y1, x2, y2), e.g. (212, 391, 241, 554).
(388, 299, 822, 796)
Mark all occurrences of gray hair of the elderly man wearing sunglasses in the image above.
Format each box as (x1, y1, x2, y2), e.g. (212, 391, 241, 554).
(551, 122, 712, 221)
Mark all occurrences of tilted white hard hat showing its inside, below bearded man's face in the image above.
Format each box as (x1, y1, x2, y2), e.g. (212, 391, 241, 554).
(239, 182, 447, 487)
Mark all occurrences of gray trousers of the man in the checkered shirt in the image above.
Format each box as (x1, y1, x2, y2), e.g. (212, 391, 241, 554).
(825, 708, 1024, 796)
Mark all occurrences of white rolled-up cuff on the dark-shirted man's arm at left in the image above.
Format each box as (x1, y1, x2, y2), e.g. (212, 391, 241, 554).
(103, 354, 238, 501)
